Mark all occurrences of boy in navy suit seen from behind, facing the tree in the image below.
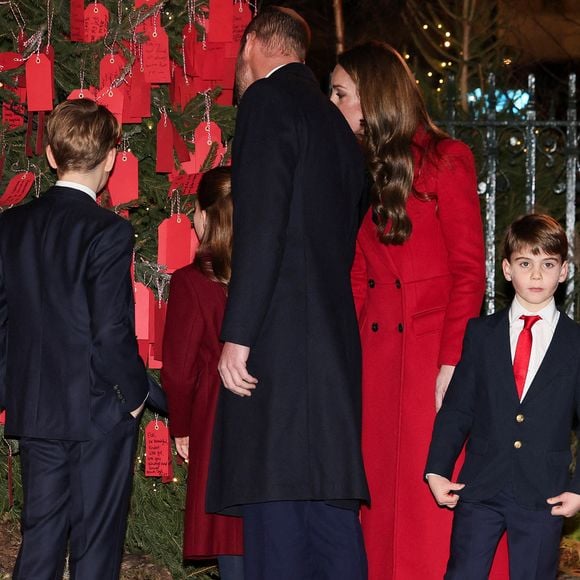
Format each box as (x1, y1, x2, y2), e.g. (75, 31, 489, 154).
(0, 99, 148, 580)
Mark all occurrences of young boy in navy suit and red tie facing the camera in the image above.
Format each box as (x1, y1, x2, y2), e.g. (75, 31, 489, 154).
(425, 214, 580, 580)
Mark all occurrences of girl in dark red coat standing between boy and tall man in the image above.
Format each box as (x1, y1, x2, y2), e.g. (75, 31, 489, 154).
(161, 167, 243, 580)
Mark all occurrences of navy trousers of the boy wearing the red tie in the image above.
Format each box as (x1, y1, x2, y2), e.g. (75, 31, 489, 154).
(445, 492, 562, 580)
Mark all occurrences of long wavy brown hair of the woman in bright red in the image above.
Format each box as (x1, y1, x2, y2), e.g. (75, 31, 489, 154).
(338, 41, 447, 244)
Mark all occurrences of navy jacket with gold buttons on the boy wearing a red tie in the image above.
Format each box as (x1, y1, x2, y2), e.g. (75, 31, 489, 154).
(425, 310, 580, 509)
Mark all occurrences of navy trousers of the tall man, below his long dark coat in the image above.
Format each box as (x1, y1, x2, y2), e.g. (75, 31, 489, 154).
(243, 501, 367, 580)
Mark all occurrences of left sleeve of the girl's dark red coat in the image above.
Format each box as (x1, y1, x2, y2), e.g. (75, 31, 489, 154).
(161, 270, 205, 437)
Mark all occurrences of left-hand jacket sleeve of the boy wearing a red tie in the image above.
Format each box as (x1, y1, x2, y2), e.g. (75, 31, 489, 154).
(425, 321, 477, 479)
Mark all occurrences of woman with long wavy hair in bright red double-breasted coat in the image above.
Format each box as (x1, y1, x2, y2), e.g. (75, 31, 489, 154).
(331, 42, 508, 580)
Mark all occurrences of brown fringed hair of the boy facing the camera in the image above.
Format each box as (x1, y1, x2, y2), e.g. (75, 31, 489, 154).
(503, 213, 568, 262)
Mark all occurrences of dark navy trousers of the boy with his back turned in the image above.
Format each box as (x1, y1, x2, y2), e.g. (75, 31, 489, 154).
(13, 415, 139, 580)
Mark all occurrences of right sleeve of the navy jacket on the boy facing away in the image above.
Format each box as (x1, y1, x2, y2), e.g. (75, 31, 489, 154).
(87, 218, 148, 412)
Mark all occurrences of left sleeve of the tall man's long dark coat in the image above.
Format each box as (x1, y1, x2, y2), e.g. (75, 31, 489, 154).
(221, 79, 298, 347)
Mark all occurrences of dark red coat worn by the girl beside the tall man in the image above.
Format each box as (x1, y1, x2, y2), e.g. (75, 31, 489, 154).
(161, 265, 242, 558)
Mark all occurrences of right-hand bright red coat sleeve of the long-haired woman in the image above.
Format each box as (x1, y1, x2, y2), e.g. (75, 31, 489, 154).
(437, 141, 485, 365)
